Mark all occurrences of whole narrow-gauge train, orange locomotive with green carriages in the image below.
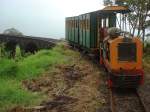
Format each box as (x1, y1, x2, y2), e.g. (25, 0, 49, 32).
(65, 6, 144, 88)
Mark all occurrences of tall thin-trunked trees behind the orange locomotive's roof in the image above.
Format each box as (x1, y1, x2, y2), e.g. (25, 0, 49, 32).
(115, 0, 150, 42)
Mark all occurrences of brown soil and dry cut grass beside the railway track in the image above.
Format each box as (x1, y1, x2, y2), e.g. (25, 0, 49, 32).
(11, 53, 107, 112)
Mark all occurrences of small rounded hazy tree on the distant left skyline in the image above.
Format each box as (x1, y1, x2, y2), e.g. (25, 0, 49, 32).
(3, 28, 23, 36)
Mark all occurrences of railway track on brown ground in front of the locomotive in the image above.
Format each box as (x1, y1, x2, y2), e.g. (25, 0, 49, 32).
(110, 89, 149, 112)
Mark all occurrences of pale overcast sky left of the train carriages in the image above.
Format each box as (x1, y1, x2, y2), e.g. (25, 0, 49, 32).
(0, 0, 103, 38)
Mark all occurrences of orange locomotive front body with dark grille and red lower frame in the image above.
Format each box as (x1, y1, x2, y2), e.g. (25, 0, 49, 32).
(101, 30, 144, 88)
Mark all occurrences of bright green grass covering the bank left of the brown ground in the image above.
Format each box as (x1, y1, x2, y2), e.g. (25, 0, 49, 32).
(0, 44, 78, 112)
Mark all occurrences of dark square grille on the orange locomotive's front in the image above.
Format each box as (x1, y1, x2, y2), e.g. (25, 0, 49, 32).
(118, 43, 137, 61)
